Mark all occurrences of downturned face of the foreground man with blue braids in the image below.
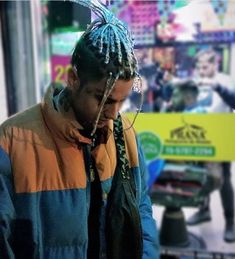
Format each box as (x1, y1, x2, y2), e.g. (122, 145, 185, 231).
(70, 69, 134, 130)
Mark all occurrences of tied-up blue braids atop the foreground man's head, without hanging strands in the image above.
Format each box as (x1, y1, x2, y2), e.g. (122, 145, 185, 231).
(72, 0, 138, 80)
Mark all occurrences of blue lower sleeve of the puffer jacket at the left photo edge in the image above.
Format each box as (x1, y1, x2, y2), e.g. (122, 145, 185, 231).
(0, 146, 15, 259)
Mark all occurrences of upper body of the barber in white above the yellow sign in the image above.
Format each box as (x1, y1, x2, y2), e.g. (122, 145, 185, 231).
(194, 48, 235, 113)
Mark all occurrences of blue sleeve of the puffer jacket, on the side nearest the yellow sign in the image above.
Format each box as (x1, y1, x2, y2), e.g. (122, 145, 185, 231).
(136, 139, 160, 259)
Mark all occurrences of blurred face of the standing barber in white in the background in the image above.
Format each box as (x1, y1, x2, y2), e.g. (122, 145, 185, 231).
(196, 54, 217, 78)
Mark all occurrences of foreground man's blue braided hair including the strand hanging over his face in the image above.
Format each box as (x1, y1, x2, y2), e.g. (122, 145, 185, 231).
(68, 0, 141, 135)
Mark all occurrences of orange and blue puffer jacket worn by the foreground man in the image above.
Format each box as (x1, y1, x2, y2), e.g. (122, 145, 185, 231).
(0, 86, 159, 259)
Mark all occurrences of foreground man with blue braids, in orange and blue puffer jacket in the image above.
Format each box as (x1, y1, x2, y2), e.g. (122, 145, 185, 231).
(0, 0, 159, 259)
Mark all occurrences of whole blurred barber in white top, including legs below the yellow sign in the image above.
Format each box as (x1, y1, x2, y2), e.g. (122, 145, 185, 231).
(187, 49, 235, 242)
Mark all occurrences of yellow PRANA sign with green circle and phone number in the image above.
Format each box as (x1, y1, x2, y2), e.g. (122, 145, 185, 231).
(127, 113, 235, 161)
